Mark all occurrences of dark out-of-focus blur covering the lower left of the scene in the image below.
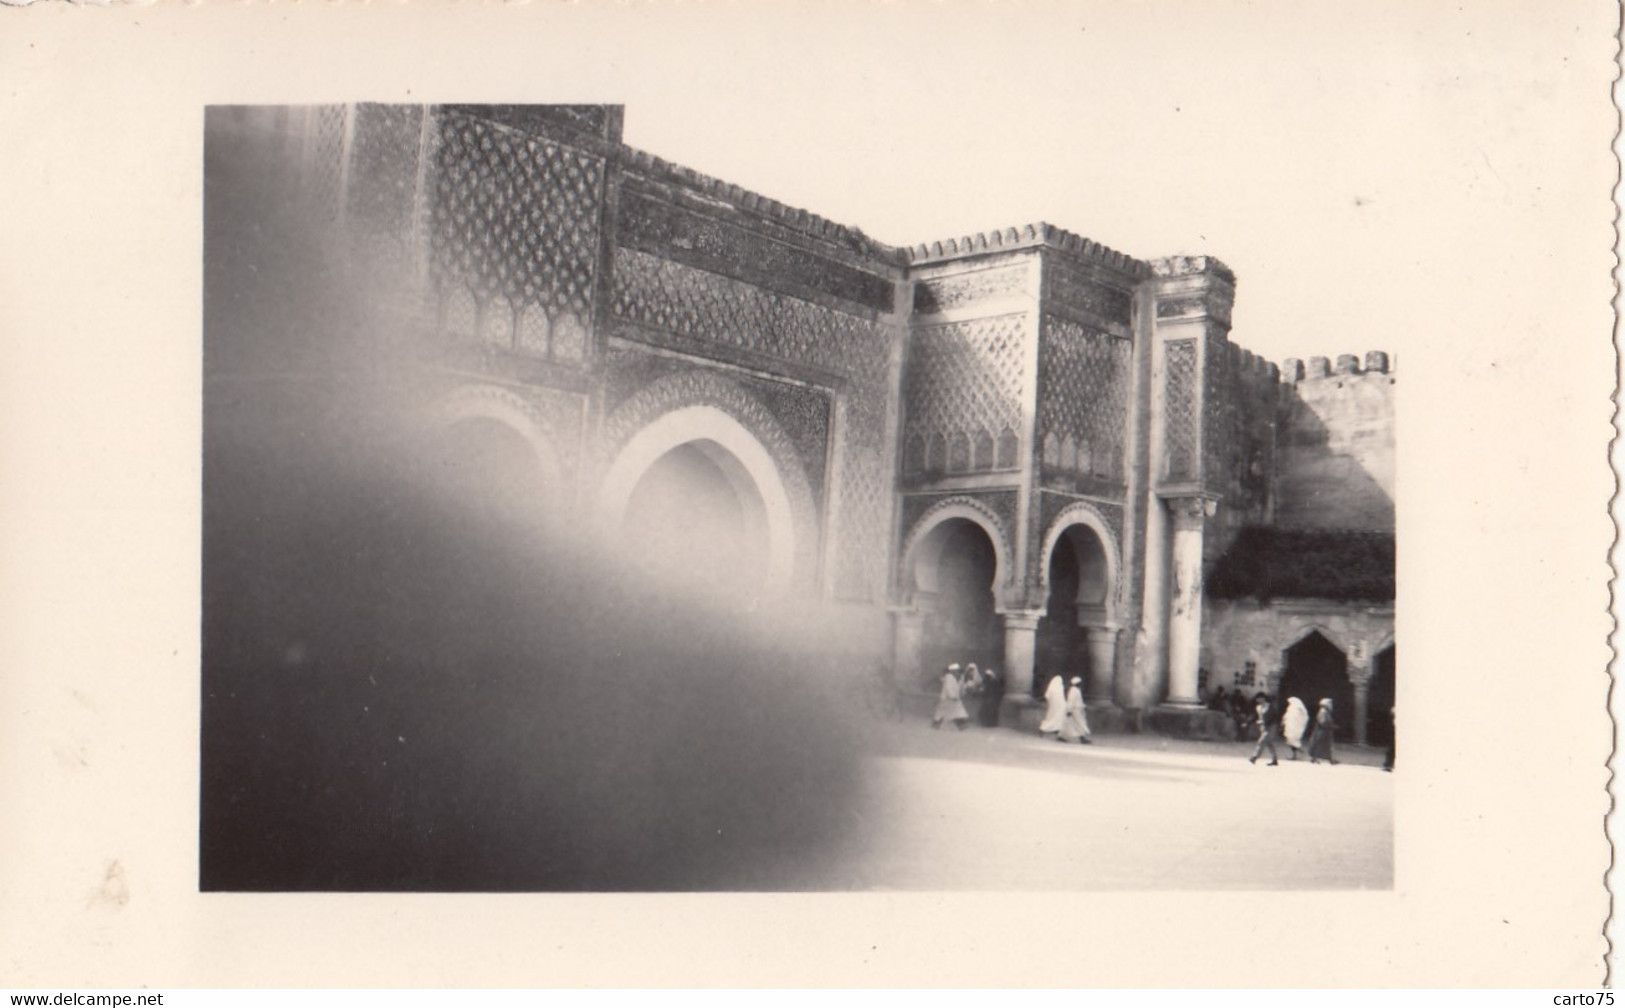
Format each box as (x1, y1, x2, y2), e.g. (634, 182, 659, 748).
(200, 109, 861, 891)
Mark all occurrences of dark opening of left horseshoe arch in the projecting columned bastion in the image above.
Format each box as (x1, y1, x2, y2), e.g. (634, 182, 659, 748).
(912, 517, 1004, 681)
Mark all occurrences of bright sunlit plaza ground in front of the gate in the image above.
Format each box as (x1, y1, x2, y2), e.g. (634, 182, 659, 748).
(842, 719, 1394, 889)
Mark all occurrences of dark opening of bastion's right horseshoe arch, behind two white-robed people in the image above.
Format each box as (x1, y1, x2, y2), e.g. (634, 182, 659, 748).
(1032, 524, 1112, 694)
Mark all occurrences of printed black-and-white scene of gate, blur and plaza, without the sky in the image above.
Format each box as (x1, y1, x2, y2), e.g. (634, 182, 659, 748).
(200, 102, 1399, 891)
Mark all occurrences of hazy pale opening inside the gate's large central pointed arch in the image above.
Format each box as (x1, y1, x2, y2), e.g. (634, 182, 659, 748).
(621, 441, 772, 595)
